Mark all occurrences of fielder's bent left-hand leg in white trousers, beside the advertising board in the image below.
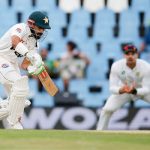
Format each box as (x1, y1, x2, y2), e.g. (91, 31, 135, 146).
(97, 94, 130, 130)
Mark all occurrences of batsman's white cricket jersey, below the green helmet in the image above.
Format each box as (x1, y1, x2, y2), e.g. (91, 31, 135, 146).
(0, 23, 38, 62)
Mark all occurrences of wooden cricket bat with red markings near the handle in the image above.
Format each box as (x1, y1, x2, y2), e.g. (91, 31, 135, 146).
(38, 69, 58, 96)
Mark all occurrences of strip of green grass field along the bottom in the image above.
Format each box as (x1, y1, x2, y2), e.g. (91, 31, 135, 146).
(0, 130, 150, 150)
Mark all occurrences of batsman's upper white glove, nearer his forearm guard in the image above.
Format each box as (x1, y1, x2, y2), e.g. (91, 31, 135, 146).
(26, 52, 43, 68)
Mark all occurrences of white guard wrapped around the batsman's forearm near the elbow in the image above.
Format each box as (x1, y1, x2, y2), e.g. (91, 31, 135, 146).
(15, 42, 28, 56)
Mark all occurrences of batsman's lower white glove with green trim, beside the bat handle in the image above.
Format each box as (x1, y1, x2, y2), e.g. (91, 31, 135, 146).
(27, 65, 45, 76)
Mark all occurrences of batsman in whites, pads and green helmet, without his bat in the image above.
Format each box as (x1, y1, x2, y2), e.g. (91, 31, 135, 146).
(0, 11, 50, 129)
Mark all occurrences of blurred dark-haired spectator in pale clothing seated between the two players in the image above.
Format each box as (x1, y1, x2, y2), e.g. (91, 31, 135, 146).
(60, 41, 90, 92)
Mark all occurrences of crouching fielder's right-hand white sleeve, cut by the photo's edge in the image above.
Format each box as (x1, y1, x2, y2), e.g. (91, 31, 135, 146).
(137, 68, 150, 96)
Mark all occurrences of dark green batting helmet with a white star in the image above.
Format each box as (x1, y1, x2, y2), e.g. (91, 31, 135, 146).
(29, 11, 51, 29)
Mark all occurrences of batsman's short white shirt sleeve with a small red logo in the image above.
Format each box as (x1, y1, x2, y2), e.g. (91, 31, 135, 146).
(11, 24, 26, 38)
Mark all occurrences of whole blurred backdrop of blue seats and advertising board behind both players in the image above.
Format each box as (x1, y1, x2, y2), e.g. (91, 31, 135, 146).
(0, 0, 150, 130)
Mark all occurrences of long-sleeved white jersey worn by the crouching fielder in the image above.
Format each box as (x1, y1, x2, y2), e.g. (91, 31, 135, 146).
(110, 59, 150, 96)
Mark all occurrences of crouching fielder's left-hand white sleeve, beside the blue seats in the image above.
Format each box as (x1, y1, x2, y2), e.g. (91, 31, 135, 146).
(109, 65, 120, 94)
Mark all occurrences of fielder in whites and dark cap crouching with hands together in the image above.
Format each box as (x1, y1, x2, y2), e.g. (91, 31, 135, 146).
(97, 45, 150, 130)
